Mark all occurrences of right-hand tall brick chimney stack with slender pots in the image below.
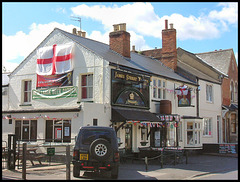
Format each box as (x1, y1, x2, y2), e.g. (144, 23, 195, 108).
(161, 20, 177, 71)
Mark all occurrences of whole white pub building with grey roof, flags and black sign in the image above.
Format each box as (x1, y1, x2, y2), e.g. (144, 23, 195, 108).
(3, 23, 202, 156)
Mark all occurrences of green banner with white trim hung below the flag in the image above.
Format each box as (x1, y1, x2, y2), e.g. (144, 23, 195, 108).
(32, 86, 78, 99)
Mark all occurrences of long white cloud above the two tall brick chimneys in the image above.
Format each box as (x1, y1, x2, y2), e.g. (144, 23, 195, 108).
(71, 2, 238, 40)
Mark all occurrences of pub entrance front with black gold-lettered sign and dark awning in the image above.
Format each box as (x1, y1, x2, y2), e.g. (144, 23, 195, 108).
(111, 70, 184, 152)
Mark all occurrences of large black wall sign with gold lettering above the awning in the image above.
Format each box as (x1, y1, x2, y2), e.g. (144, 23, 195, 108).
(112, 70, 150, 108)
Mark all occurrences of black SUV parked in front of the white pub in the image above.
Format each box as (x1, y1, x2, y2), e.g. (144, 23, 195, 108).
(72, 126, 119, 179)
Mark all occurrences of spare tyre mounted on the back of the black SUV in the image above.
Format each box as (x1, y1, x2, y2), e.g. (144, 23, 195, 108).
(90, 138, 112, 161)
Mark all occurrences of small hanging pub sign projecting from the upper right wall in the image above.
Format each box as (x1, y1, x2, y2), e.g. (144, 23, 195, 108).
(175, 85, 191, 107)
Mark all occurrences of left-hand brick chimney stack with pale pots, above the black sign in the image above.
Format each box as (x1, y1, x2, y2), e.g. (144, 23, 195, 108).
(109, 23, 130, 58)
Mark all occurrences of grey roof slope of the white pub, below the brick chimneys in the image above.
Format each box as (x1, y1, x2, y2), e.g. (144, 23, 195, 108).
(56, 28, 194, 84)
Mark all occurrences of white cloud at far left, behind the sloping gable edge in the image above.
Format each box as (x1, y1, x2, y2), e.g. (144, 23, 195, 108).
(2, 22, 75, 71)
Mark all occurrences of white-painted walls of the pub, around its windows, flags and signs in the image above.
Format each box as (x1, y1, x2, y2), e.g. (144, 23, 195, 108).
(2, 29, 221, 152)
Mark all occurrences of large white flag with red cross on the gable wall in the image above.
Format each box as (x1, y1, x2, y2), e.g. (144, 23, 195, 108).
(36, 44, 73, 75)
